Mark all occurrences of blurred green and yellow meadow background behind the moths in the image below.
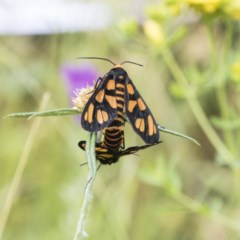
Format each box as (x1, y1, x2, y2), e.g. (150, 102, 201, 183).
(0, 0, 240, 240)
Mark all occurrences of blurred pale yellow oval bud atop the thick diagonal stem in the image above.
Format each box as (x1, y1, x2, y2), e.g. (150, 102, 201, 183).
(143, 20, 165, 46)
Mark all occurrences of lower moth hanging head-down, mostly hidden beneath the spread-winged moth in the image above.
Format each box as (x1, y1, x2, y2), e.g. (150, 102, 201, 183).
(78, 141, 161, 165)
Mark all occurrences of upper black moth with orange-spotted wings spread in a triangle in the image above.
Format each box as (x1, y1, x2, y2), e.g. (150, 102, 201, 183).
(81, 58, 159, 144)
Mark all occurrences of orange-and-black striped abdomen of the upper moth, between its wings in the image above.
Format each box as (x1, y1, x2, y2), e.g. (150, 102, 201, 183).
(102, 74, 125, 150)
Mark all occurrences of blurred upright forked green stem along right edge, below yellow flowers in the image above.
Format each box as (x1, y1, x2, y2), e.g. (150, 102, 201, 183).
(204, 20, 240, 200)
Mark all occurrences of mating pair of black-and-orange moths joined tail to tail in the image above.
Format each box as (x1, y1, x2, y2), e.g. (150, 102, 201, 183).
(78, 58, 160, 164)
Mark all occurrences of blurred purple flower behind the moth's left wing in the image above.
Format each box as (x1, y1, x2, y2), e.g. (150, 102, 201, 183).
(61, 63, 99, 105)
